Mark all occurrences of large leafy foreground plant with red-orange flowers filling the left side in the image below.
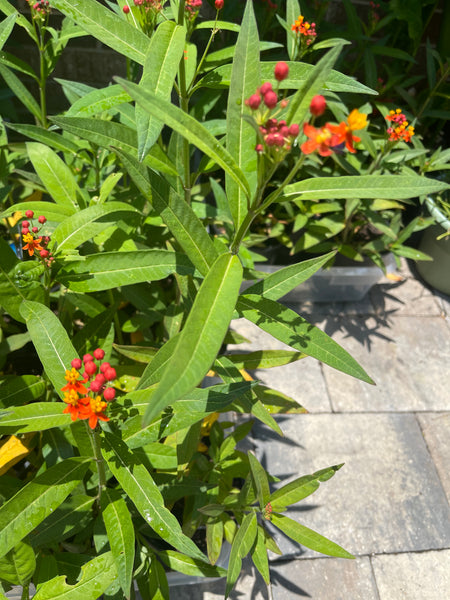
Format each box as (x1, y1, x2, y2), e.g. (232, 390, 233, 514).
(0, 0, 447, 600)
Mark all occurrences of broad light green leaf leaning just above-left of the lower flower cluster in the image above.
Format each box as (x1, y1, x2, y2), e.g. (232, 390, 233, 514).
(20, 300, 77, 398)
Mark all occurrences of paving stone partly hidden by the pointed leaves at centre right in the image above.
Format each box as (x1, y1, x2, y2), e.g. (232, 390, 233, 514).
(232, 319, 331, 412)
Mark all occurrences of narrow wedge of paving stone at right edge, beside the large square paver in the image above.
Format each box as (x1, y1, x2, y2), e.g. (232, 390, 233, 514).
(417, 413, 450, 502)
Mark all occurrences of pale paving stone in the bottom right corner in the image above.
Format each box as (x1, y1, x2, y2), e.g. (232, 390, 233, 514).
(372, 550, 450, 600)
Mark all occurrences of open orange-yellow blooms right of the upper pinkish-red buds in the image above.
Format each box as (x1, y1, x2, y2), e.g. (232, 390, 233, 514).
(301, 105, 367, 156)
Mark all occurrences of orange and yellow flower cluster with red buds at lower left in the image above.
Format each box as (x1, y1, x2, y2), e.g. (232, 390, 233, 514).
(61, 348, 117, 429)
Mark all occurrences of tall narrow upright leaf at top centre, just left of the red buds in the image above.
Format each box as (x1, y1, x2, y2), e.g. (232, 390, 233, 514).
(226, 2, 261, 230)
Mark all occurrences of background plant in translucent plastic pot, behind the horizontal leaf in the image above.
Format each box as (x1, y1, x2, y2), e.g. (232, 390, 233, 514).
(243, 99, 445, 302)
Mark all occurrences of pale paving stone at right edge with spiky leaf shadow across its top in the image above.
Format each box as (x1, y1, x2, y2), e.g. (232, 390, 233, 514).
(323, 317, 450, 412)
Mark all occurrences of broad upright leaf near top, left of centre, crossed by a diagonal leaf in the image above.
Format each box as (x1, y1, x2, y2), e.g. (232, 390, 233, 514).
(136, 21, 186, 160)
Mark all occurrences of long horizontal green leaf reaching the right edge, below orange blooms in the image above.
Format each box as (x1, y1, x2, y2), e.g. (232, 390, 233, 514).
(281, 175, 449, 201)
